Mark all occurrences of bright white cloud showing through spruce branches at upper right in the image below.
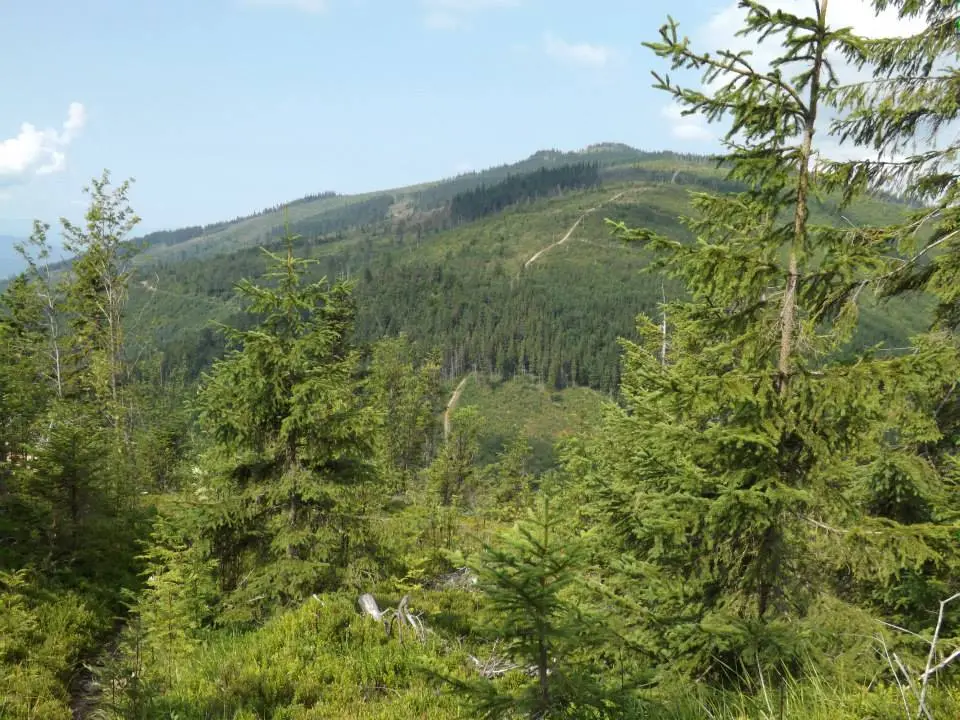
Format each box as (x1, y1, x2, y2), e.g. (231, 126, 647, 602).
(663, 0, 925, 150)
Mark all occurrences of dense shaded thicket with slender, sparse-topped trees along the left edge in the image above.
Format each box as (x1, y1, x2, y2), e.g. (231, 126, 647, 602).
(0, 173, 176, 720)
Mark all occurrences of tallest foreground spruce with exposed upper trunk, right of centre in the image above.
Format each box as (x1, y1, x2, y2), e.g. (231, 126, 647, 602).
(568, 0, 958, 681)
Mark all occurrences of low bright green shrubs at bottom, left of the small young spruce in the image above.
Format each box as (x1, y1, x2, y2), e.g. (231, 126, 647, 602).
(104, 592, 488, 720)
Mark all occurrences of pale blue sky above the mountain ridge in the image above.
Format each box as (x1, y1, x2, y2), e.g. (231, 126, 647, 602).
(0, 0, 928, 235)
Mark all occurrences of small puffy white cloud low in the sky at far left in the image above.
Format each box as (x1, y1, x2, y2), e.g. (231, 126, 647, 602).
(0, 102, 87, 184)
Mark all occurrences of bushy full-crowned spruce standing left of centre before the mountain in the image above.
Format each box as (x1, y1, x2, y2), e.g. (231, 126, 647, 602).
(193, 236, 374, 620)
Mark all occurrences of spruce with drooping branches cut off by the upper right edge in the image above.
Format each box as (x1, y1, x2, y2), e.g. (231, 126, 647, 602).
(833, 0, 960, 478)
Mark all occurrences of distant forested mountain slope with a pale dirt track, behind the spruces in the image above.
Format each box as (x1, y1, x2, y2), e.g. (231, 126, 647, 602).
(120, 144, 922, 392)
